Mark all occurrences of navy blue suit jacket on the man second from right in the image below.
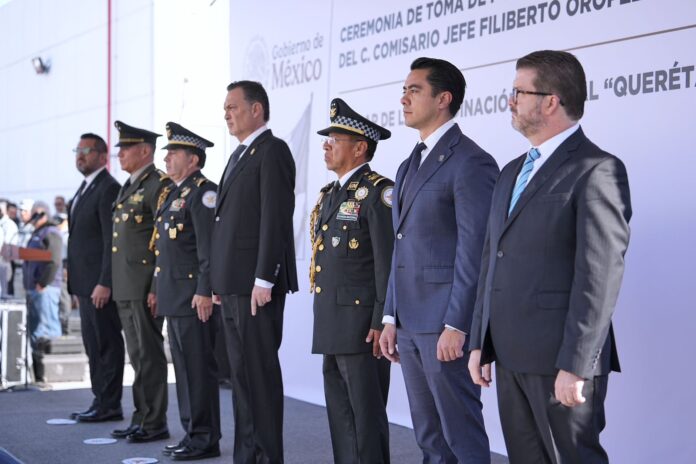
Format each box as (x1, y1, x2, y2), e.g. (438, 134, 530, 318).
(384, 125, 498, 333)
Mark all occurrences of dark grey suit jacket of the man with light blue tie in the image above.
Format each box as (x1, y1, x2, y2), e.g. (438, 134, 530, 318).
(470, 129, 631, 378)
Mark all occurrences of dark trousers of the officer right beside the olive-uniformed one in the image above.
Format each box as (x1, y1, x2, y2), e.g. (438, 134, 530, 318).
(167, 311, 220, 450)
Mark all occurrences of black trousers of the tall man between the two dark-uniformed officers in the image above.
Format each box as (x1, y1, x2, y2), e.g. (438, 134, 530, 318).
(221, 294, 285, 464)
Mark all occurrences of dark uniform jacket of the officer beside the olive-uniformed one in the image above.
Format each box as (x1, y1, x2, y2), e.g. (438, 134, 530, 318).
(155, 172, 217, 316)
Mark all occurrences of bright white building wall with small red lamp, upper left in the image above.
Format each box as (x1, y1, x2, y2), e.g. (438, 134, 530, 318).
(0, 0, 154, 204)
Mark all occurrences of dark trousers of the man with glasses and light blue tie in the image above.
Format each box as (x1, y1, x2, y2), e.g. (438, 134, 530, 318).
(495, 362, 609, 464)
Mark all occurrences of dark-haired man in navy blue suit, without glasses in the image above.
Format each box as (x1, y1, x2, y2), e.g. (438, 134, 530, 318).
(380, 58, 498, 463)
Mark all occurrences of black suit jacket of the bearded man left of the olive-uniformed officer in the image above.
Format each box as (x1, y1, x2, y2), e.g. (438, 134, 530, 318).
(68, 169, 121, 297)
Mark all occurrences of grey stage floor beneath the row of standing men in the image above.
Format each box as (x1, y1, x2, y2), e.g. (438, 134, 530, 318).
(0, 385, 507, 464)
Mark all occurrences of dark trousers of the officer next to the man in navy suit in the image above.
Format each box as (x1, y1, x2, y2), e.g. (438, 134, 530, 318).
(323, 352, 391, 464)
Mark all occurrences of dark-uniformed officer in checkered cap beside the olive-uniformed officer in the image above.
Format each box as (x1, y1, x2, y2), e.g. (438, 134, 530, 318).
(155, 122, 220, 460)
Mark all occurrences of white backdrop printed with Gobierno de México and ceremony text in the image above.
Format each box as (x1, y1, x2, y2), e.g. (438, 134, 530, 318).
(230, 0, 696, 463)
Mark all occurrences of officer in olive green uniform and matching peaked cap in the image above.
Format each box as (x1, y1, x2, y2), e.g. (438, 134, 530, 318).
(111, 121, 171, 443)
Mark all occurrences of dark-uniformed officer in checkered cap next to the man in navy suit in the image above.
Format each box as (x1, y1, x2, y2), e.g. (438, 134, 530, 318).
(310, 98, 394, 464)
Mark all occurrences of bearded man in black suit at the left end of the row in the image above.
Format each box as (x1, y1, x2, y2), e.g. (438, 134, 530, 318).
(68, 134, 125, 422)
